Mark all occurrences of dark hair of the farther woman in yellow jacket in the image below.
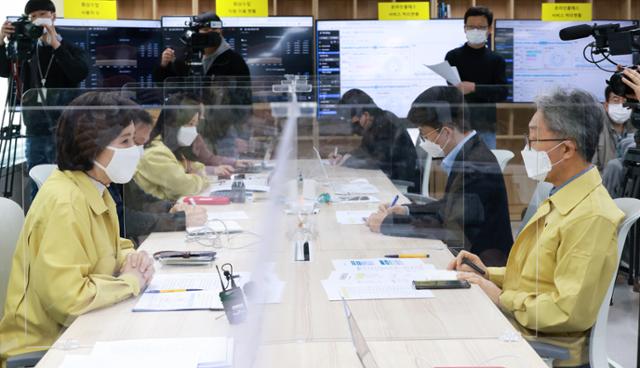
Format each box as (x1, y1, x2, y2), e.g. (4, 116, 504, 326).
(149, 92, 202, 152)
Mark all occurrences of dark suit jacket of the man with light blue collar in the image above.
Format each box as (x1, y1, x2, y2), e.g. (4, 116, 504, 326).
(381, 135, 513, 265)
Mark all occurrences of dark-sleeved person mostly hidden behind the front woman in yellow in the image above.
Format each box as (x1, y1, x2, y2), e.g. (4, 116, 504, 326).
(109, 102, 207, 247)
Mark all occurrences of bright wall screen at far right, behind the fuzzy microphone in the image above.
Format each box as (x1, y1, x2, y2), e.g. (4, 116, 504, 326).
(495, 19, 634, 102)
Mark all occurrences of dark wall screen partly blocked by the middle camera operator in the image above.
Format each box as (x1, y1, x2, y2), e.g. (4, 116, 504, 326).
(162, 17, 313, 77)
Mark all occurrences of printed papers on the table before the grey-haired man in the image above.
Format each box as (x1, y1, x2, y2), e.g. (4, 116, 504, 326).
(322, 258, 456, 300)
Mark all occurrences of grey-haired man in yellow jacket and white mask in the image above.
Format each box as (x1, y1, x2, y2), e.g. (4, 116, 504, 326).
(449, 90, 624, 368)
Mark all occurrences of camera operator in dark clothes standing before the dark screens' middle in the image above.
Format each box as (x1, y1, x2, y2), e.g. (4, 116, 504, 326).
(153, 13, 253, 158)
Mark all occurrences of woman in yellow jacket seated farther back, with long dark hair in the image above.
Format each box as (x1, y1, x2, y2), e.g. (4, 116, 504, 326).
(134, 93, 209, 200)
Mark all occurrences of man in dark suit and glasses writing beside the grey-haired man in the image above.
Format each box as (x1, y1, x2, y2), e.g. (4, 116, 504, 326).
(367, 86, 513, 265)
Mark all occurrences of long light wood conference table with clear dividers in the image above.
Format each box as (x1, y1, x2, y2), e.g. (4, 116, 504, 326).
(33, 164, 546, 368)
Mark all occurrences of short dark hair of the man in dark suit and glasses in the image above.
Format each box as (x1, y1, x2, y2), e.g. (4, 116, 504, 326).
(407, 86, 470, 132)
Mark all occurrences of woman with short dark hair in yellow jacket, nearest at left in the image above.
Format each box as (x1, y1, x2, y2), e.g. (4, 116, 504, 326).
(0, 92, 154, 367)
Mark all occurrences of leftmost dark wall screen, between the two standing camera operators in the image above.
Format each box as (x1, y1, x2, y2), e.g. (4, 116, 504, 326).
(8, 17, 162, 88)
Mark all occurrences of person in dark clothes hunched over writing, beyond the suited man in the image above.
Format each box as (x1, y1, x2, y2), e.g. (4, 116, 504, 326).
(329, 89, 418, 188)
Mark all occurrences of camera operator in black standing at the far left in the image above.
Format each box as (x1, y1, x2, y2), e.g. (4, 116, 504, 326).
(0, 0, 89, 197)
